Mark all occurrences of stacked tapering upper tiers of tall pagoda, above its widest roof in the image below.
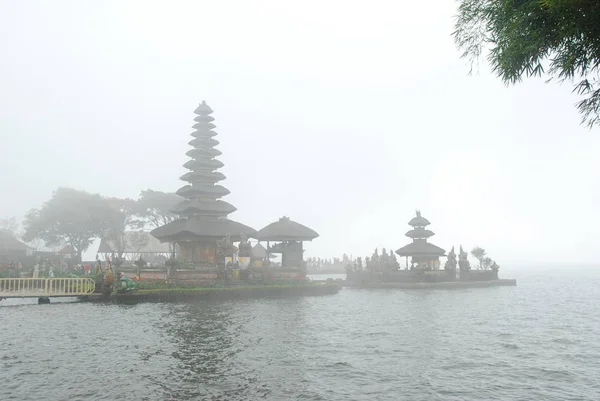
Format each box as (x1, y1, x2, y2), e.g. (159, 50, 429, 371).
(173, 101, 236, 220)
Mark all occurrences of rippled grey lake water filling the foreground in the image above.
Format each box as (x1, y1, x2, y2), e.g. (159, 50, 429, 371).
(0, 268, 600, 401)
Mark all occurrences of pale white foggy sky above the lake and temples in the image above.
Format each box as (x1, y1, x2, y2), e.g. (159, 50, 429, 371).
(0, 0, 600, 266)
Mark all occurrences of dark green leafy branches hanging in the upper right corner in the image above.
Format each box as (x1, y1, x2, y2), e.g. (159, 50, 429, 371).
(453, 0, 600, 128)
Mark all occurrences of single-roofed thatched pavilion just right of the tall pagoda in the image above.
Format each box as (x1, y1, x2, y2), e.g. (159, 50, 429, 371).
(253, 217, 319, 268)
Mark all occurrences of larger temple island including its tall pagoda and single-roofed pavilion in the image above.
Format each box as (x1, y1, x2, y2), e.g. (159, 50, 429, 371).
(88, 101, 340, 302)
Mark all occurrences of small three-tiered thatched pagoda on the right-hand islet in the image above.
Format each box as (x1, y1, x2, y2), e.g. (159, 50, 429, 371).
(396, 210, 446, 270)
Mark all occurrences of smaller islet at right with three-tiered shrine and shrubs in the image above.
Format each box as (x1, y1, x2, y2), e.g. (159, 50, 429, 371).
(345, 210, 517, 288)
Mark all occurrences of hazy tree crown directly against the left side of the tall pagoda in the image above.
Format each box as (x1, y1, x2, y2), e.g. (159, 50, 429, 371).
(136, 189, 183, 228)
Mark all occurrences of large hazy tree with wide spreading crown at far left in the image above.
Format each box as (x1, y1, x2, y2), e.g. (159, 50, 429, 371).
(23, 188, 119, 261)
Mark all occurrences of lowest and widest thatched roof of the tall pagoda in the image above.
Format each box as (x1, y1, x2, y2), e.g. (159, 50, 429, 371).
(150, 217, 256, 242)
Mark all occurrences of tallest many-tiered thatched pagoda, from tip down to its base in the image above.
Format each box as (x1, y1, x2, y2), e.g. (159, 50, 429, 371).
(152, 101, 256, 265)
